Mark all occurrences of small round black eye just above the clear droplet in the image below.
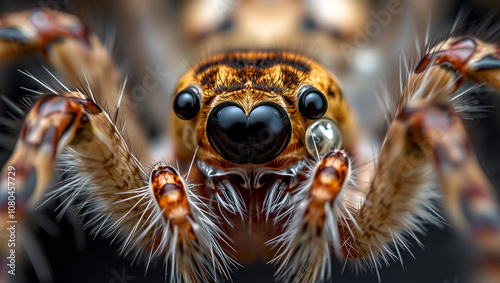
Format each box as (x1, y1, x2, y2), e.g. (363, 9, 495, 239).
(299, 87, 328, 120)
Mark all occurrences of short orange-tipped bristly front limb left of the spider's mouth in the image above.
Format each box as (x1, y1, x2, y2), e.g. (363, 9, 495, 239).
(149, 163, 233, 282)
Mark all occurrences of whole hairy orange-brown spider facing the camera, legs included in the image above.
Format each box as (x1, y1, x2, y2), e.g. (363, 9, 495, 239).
(0, 3, 500, 282)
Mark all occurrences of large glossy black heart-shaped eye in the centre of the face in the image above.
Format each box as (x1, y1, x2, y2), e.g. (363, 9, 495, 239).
(207, 102, 292, 164)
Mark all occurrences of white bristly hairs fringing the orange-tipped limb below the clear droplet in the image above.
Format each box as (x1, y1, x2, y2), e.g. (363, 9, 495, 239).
(266, 155, 355, 282)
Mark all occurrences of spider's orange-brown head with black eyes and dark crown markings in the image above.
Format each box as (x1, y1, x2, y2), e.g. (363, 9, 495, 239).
(171, 52, 354, 172)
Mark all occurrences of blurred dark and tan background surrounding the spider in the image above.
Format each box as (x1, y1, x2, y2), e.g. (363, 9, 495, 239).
(0, 0, 500, 283)
